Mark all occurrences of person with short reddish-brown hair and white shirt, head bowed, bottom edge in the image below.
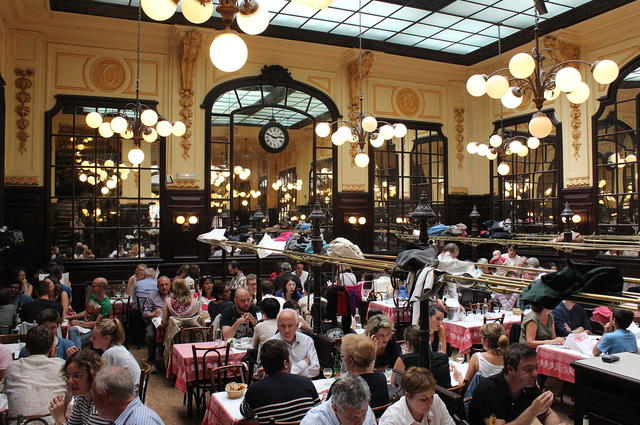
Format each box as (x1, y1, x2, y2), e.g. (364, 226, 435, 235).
(379, 367, 455, 425)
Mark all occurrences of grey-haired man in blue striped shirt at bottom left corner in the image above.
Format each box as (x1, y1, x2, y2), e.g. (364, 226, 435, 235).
(91, 366, 164, 425)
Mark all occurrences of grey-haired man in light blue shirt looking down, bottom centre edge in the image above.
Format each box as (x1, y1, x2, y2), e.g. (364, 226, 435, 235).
(300, 376, 376, 425)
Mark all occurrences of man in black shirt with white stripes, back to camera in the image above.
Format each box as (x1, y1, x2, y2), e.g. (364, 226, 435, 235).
(240, 339, 320, 425)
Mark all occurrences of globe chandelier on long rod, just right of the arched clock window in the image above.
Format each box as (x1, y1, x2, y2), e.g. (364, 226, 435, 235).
(316, 0, 407, 168)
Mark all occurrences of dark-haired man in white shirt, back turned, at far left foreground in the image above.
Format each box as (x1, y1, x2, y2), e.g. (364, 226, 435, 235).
(5, 325, 67, 423)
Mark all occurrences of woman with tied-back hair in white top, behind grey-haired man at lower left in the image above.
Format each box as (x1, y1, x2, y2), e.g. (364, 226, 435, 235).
(91, 319, 140, 391)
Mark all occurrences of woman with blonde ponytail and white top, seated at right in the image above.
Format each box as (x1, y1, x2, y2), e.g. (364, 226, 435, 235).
(464, 323, 509, 382)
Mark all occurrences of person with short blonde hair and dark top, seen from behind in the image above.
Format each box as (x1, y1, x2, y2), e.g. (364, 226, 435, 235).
(340, 334, 389, 407)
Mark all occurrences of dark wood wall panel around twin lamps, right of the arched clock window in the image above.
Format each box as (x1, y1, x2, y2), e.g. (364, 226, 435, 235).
(327, 192, 373, 252)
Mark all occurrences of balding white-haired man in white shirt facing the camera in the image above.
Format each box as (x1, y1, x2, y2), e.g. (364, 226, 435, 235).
(273, 308, 320, 378)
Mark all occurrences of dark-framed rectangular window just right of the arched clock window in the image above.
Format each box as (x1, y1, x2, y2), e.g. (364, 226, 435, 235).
(369, 118, 447, 252)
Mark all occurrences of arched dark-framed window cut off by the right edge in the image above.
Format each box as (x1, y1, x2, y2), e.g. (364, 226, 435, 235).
(592, 56, 640, 234)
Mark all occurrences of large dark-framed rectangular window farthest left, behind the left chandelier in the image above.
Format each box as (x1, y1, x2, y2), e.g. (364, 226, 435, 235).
(45, 95, 165, 260)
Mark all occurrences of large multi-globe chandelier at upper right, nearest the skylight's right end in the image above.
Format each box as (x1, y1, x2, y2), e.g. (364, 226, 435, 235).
(467, 1, 618, 139)
